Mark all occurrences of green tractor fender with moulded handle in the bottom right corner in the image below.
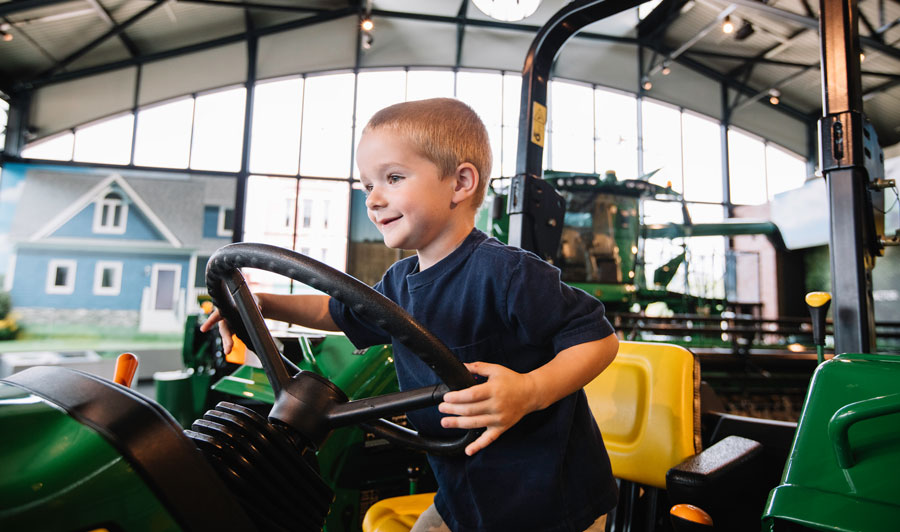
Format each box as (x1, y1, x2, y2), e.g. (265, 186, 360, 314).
(763, 355, 900, 532)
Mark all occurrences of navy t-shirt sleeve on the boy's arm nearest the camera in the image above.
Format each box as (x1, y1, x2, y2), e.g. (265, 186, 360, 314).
(506, 253, 615, 353)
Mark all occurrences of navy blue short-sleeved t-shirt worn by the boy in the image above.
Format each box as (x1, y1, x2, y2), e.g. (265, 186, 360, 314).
(329, 229, 616, 532)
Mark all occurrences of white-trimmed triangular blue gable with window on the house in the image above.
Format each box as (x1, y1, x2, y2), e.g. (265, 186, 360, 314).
(30, 174, 182, 247)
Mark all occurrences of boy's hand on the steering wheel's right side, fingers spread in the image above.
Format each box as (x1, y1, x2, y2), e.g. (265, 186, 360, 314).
(438, 362, 538, 456)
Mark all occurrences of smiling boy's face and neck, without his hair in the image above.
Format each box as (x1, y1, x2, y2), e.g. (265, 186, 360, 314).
(357, 128, 473, 269)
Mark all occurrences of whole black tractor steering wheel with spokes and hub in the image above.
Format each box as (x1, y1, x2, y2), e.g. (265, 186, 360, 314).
(206, 243, 481, 454)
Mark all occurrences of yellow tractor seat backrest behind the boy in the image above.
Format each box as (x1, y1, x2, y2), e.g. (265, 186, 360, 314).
(584, 342, 700, 488)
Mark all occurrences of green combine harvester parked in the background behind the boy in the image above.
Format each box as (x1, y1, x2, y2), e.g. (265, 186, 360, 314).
(479, 171, 778, 314)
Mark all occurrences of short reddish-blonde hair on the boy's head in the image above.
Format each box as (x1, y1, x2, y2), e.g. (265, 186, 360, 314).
(363, 98, 492, 209)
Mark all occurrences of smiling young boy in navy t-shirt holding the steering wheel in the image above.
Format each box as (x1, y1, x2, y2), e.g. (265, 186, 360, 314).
(202, 98, 618, 532)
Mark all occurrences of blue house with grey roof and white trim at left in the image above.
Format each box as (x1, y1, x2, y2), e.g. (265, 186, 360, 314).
(6, 169, 234, 332)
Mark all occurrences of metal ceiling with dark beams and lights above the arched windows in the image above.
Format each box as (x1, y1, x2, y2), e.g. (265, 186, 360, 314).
(0, 0, 900, 145)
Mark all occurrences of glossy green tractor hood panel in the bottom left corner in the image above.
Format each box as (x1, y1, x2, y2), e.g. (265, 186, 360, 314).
(0, 383, 180, 532)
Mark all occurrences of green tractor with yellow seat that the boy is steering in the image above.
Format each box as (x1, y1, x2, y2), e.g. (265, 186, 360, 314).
(0, 0, 900, 532)
